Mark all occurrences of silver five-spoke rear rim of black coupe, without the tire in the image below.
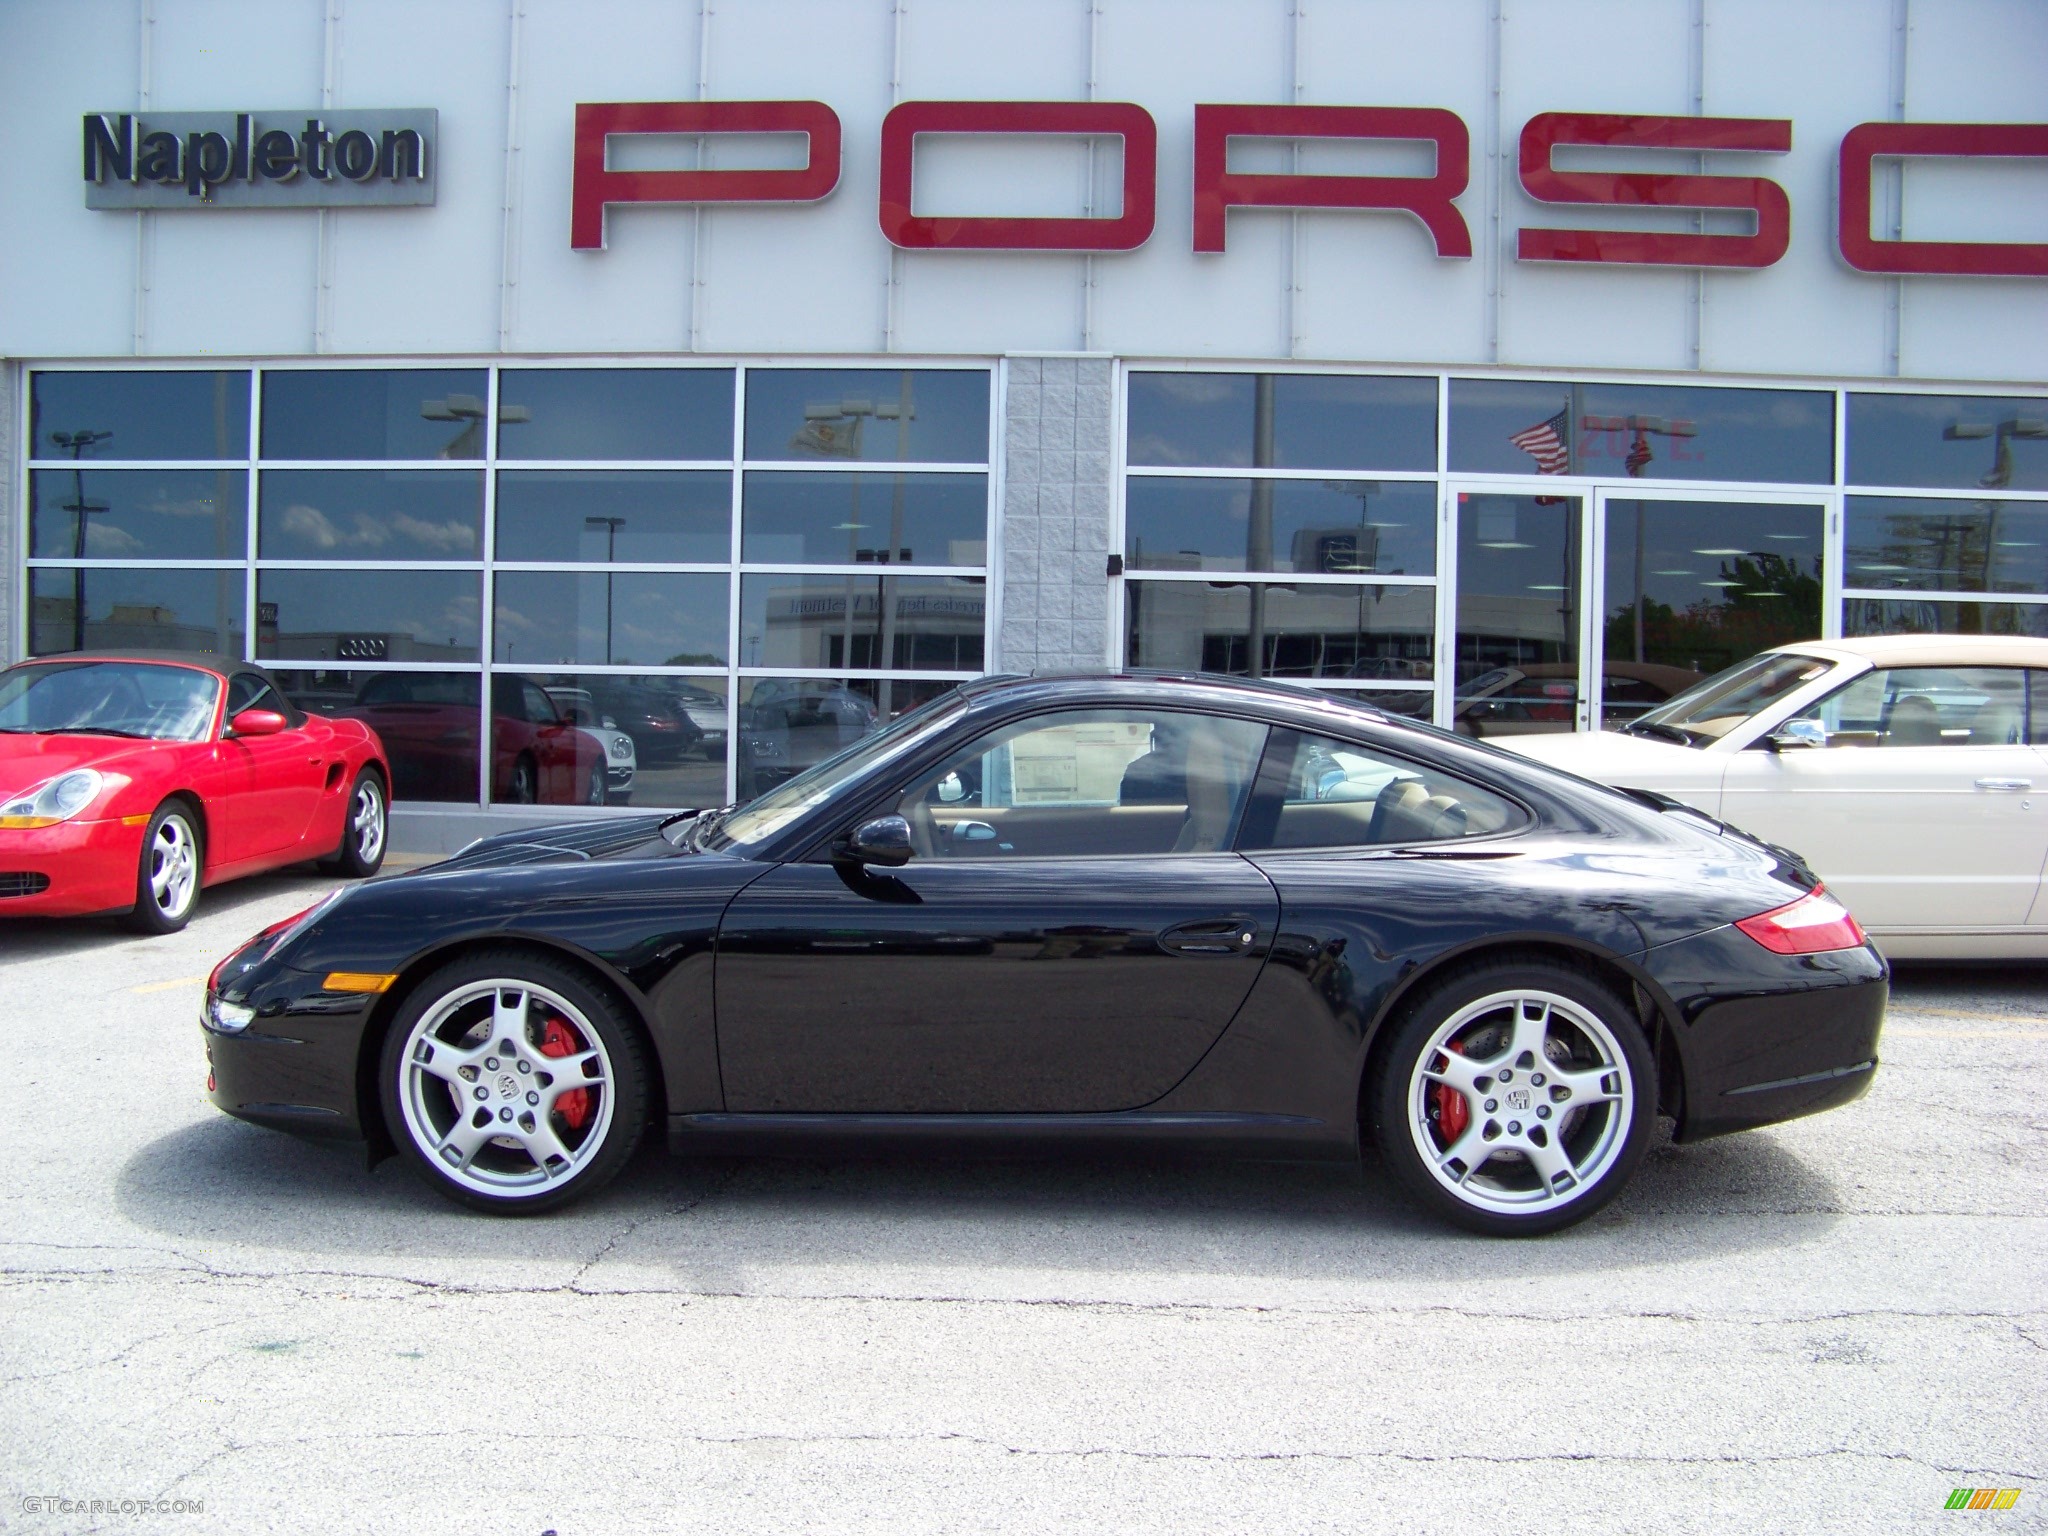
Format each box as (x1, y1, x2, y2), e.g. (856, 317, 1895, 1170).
(1407, 989, 1636, 1214)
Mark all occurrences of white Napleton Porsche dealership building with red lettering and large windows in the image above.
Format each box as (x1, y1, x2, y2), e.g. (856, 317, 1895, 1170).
(0, 0, 2048, 848)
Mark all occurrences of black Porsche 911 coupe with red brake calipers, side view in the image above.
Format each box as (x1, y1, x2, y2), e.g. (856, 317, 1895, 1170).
(205, 676, 1886, 1233)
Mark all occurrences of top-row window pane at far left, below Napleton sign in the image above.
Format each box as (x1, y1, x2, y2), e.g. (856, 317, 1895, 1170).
(29, 369, 250, 459)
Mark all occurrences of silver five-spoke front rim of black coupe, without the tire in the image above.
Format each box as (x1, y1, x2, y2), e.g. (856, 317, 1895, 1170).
(397, 977, 612, 1200)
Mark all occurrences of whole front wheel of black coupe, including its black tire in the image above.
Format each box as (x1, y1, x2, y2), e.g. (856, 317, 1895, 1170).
(377, 948, 647, 1214)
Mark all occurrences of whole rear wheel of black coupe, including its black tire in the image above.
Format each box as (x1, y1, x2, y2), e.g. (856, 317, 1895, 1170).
(1366, 961, 1657, 1237)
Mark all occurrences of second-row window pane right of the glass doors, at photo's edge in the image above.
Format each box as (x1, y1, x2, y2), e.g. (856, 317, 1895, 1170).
(1843, 496, 2048, 592)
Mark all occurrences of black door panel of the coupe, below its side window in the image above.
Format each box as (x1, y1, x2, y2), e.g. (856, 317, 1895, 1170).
(717, 854, 1280, 1114)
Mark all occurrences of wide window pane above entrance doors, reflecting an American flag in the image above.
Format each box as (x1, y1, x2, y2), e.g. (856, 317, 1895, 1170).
(1450, 379, 1835, 485)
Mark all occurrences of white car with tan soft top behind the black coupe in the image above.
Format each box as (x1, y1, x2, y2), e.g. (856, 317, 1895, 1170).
(1495, 635, 2048, 958)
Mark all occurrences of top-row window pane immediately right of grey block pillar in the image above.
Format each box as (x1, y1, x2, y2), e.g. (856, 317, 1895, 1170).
(1126, 373, 1436, 471)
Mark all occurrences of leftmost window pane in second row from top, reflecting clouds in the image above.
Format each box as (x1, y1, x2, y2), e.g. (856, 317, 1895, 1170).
(29, 469, 248, 559)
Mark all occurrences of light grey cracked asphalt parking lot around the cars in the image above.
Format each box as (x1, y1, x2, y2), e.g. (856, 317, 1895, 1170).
(0, 874, 2048, 1536)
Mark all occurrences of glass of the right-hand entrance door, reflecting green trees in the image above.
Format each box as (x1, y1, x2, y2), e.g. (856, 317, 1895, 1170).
(1602, 498, 1827, 692)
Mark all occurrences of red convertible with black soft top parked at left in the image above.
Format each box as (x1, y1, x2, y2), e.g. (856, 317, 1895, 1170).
(0, 651, 391, 934)
